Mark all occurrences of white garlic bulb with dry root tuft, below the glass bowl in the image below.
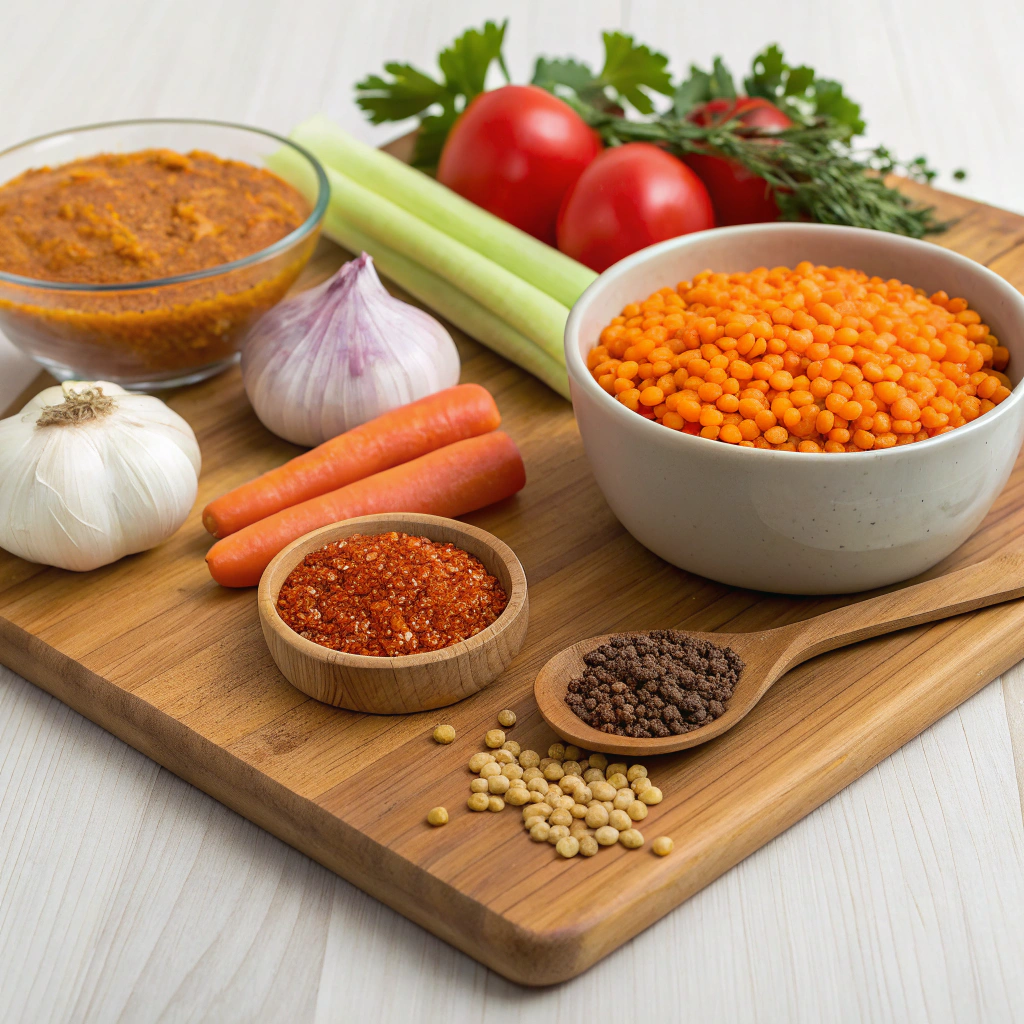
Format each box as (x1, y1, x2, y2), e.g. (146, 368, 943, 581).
(0, 381, 200, 570)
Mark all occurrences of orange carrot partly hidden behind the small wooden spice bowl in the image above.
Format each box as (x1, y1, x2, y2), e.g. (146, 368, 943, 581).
(206, 430, 526, 587)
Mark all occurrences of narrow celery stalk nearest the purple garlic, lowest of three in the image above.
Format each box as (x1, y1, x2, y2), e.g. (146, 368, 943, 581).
(324, 207, 569, 398)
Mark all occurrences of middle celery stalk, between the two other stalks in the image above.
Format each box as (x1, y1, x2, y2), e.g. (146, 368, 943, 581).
(326, 161, 568, 364)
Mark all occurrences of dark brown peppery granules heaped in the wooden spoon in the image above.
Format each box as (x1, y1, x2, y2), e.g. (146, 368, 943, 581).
(565, 630, 743, 738)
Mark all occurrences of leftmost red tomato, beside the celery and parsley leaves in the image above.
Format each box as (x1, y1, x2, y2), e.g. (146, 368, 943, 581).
(437, 85, 601, 246)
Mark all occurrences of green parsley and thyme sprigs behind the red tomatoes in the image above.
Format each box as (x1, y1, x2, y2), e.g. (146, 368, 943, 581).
(355, 22, 964, 238)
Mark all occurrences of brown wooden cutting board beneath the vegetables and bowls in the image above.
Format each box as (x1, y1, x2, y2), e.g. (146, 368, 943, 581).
(0, 182, 1024, 985)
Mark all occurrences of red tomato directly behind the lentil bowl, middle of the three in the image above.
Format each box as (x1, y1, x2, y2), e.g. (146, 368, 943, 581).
(558, 142, 715, 271)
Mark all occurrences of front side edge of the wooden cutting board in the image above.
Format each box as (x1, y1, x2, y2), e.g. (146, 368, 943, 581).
(0, 606, 1024, 987)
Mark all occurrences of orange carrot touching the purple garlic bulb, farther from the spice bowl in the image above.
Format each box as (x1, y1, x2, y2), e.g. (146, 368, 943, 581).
(203, 384, 502, 537)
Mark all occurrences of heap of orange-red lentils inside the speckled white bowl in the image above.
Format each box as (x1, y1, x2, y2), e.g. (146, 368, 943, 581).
(587, 262, 1011, 452)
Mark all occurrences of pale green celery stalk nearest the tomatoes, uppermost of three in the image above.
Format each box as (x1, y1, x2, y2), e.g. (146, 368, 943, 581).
(292, 115, 597, 306)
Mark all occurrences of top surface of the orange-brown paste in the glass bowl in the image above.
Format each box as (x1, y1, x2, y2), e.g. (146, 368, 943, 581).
(0, 150, 309, 284)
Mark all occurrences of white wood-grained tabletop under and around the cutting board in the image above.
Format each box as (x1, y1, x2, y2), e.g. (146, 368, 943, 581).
(0, 0, 1024, 1024)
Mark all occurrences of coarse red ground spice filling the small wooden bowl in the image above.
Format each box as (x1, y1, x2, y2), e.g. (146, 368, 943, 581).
(278, 532, 508, 657)
